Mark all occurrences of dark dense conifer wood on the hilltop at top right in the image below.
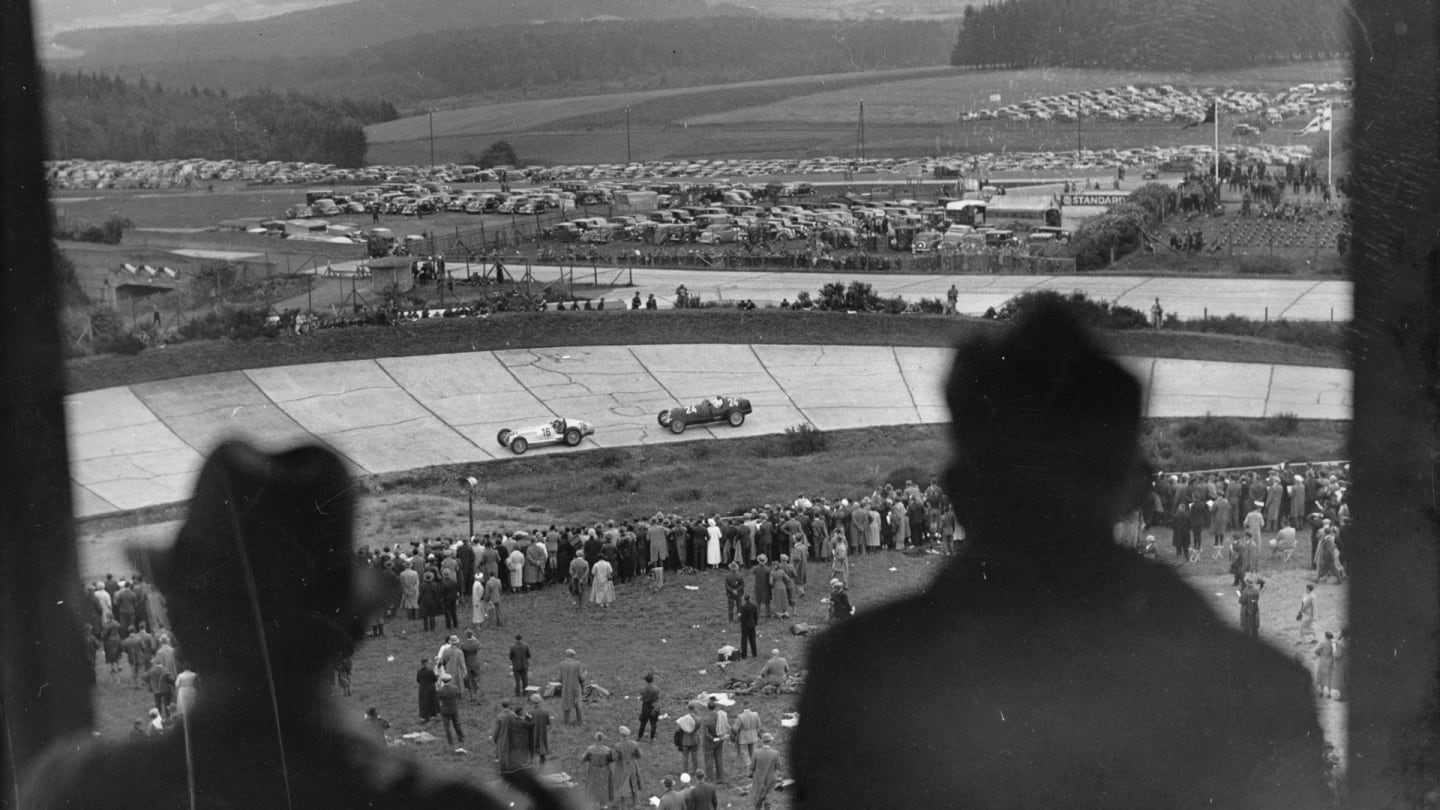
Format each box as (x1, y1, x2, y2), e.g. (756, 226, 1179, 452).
(950, 0, 1349, 71)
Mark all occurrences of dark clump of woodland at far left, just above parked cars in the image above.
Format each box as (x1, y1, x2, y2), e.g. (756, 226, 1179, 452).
(45, 74, 397, 167)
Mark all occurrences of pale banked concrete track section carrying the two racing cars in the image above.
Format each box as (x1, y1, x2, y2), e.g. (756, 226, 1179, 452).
(66, 344, 1351, 517)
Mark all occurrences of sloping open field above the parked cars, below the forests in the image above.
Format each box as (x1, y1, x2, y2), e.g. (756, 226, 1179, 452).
(367, 61, 1349, 163)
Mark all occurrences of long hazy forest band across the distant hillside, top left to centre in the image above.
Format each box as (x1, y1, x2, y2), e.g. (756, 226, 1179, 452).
(75, 17, 955, 104)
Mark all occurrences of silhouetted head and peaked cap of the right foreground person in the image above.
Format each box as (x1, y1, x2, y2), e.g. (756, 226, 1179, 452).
(945, 304, 1146, 545)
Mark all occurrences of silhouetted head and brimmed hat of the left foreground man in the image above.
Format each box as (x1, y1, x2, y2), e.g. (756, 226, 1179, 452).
(142, 441, 386, 680)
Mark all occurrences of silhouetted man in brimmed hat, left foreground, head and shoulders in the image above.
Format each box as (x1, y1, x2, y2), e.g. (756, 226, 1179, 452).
(24, 442, 559, 810)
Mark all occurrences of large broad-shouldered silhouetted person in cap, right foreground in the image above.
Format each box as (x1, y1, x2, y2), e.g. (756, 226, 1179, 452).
(789, 304, 1326, 810)
